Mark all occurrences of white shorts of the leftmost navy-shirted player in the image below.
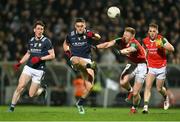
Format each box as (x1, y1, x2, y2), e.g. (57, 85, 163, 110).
(22, 65, 45, 84)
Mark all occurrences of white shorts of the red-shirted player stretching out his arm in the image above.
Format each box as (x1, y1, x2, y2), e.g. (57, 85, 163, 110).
(121, 63, 147, 83)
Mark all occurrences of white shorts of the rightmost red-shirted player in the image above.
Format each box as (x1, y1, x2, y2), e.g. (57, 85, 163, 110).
(148, 66, 166, 80)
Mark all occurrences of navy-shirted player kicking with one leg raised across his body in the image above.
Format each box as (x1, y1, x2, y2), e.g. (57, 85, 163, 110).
(63, 18, 101, 114)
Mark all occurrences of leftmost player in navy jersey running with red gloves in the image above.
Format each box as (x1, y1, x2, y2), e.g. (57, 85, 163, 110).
(9, 21, 55, 112)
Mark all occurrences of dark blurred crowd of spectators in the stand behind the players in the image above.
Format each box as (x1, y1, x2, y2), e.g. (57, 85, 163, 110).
(0, 0, 180, 64)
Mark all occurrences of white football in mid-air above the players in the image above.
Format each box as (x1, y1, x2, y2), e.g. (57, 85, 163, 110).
(107, 6, 121, 18)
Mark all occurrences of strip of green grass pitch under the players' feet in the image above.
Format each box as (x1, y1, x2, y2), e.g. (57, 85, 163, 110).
(0, 106, 180, 121)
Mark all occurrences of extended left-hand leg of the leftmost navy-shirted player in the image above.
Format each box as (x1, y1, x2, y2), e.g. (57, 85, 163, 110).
(9, 73, 31, 112)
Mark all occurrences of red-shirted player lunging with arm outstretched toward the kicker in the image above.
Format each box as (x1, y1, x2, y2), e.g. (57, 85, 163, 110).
(96, 27, 147, 113)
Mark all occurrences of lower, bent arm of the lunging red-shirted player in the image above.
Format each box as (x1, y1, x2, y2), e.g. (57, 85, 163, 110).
(120, 43, 137, 55)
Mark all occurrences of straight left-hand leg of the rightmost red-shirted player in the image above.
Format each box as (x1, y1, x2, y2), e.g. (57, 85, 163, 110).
(143, 72, 155, 114)
